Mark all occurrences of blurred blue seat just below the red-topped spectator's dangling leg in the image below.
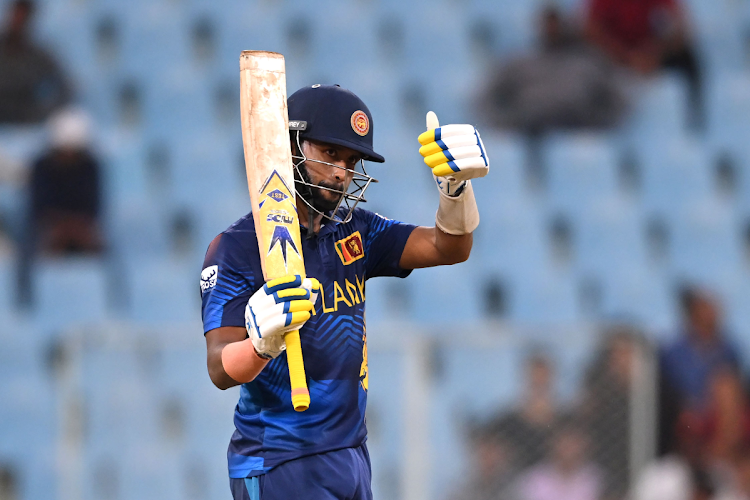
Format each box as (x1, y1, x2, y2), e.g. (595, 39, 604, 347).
(640, 139, 714, 215)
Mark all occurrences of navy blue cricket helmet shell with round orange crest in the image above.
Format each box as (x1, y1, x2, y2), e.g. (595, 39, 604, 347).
(287, 85, 385, 163)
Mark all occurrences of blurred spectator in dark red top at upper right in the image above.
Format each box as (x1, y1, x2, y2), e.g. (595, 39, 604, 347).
(586, 0, 703, 128)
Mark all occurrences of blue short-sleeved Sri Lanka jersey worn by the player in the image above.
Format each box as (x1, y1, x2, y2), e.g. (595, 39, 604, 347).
(201, 209, 415, 478)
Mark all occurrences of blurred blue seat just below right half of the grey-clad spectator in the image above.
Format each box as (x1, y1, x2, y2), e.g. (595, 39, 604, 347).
(543, 134, 617, 213)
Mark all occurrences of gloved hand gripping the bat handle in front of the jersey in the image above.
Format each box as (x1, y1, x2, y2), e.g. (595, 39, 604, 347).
(245, 274, 320, 358)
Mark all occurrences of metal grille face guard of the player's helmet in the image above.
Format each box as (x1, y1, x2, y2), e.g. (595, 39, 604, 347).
(292, 131, 378, 223)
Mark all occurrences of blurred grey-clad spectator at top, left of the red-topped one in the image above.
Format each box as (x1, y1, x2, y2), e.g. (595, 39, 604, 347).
(480, 7, 625, 135)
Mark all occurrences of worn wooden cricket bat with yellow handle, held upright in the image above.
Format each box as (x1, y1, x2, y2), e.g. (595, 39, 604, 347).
(240, 50, 310, 411)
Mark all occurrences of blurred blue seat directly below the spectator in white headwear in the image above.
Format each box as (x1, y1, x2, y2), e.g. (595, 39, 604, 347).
(33, 257, 108, 330)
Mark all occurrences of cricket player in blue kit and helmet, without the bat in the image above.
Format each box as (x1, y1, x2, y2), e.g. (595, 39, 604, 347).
(200, 85, 489, 500)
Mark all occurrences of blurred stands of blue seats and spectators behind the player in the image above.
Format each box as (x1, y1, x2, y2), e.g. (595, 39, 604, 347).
(0, 0, 750, 500)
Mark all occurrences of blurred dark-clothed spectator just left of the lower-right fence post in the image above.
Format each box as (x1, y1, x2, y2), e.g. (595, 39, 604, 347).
(580, 326, 642, 500)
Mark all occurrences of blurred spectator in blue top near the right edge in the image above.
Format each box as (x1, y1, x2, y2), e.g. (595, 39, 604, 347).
(659, 287, 741, 453)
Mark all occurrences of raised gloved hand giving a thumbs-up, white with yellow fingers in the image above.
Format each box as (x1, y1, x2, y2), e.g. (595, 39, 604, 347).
(418, 111, 490, 196)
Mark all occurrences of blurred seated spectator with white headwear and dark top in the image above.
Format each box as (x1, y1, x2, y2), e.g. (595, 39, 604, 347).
(30, 110, 102, 254)
